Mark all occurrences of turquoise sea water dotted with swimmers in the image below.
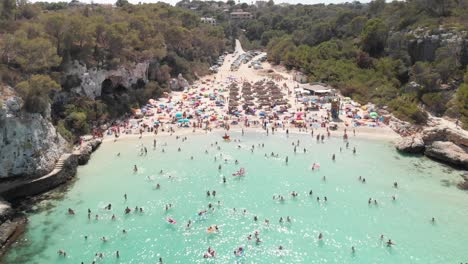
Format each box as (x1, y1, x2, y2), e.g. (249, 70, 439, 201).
(6, 132, 468, 263)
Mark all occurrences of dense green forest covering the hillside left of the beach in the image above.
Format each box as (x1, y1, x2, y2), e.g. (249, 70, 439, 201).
(0, 0, 229, 140)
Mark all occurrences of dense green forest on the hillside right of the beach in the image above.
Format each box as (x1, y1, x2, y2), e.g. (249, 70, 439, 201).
(229, 0, 468, 128)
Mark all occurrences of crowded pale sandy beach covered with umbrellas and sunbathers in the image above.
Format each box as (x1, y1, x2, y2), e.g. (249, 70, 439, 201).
(99, 40, 400, 142)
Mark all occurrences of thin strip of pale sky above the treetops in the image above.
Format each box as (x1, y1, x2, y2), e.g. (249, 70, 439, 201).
(31, 0, 370, 5)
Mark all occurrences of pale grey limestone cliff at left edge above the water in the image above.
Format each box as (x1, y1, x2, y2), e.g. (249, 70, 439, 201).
(0, 88, 68, 179)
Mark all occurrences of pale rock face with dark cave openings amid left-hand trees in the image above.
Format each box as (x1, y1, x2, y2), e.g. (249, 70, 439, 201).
(65, 61, 149, 99)
